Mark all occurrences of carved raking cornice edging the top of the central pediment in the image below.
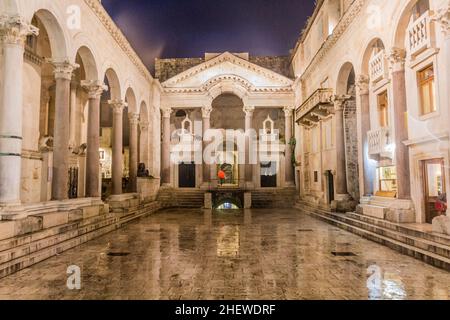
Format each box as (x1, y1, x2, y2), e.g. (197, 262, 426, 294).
(163, 52, 293, 88)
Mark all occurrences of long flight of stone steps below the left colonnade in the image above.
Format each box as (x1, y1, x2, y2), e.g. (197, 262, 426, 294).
(0, 202, 160, 278)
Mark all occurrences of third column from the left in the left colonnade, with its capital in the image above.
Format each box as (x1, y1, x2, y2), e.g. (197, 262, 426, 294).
(81, 81, 108, 198)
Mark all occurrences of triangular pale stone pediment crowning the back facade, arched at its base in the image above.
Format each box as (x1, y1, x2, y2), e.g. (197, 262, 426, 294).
(162, 52, 293, 89)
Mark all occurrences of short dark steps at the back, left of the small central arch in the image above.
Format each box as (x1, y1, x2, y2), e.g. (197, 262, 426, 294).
(157, 188, 205, 208)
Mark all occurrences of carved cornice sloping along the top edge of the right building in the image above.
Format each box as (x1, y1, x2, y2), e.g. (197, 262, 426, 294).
(301, 0, 368, 80)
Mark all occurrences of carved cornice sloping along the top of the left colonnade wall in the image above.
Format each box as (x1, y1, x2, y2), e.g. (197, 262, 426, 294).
(84, 0, 153, 82)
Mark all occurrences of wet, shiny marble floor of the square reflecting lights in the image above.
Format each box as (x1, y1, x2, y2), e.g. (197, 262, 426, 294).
(0, 210, 450, 300)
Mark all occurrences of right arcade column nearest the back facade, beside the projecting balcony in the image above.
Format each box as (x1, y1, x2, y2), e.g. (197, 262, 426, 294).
(333, 95, 350, 200)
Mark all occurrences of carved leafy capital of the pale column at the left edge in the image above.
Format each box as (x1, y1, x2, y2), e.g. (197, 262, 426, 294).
(0, 15, 39, 46)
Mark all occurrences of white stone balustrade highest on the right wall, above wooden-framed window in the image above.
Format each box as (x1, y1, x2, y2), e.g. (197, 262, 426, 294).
(408, 11, 434, 56)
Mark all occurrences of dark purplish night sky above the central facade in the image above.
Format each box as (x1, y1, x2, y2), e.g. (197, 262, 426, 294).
(102, 0, 315, 70)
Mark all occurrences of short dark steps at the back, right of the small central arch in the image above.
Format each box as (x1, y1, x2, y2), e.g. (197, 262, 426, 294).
(252, 188, 297, 209)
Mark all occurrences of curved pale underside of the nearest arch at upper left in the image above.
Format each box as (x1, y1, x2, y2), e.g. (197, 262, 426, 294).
(33, 9, 68, 60)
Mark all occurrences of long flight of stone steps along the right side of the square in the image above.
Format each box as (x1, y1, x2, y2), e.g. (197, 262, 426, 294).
(295, 201, 450, 271)
